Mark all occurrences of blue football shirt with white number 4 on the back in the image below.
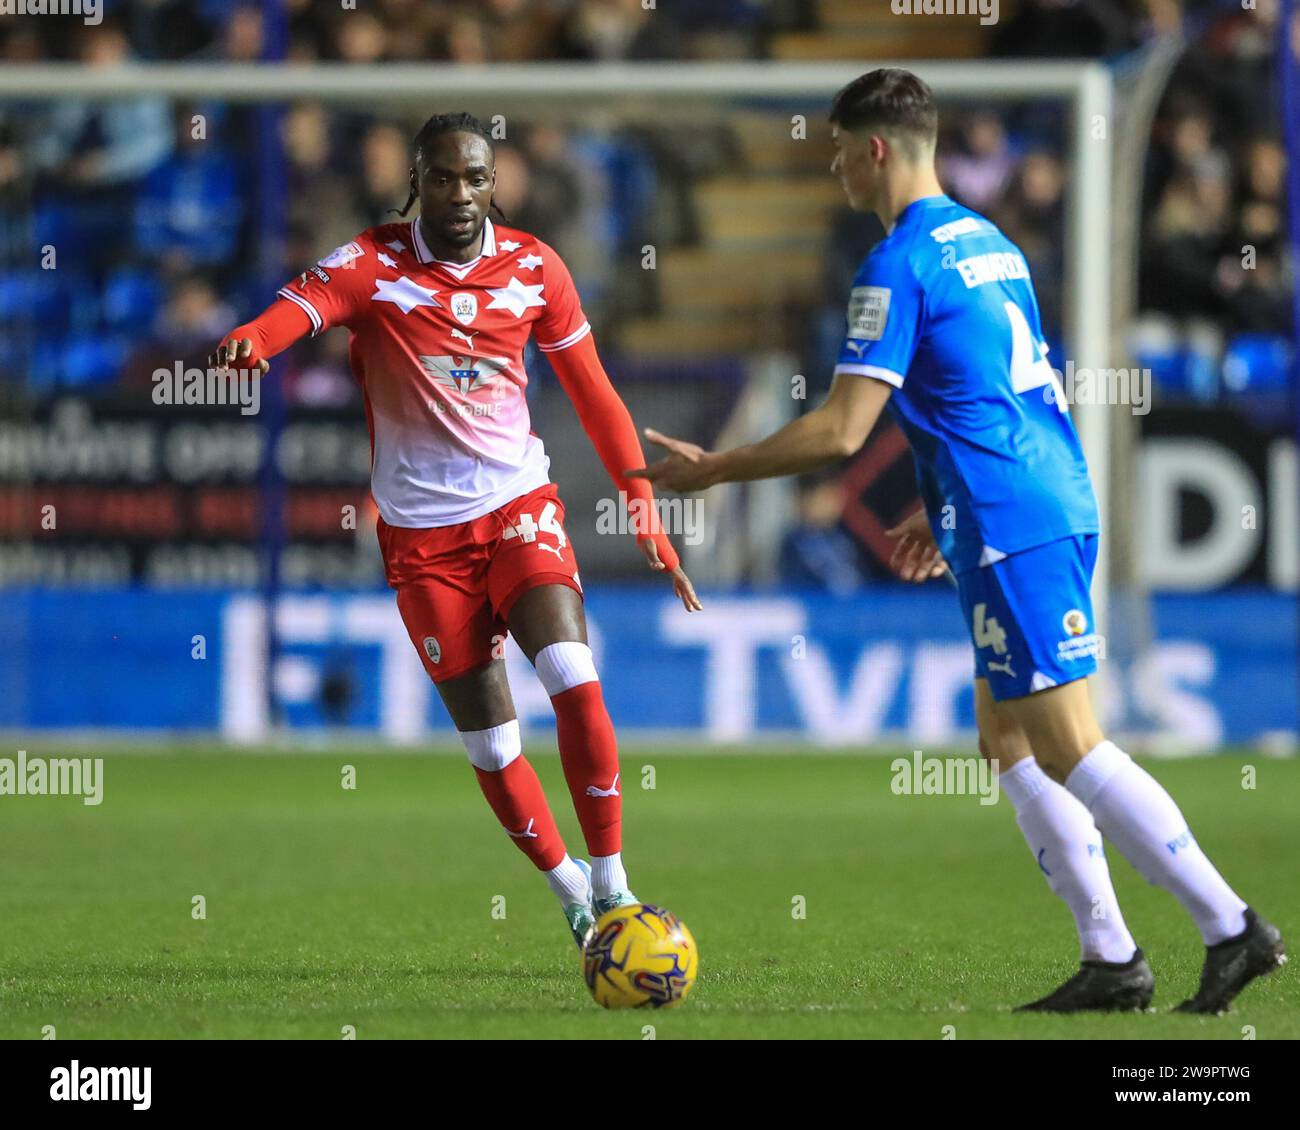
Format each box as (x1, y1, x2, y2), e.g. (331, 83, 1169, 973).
(835, 196, 1099, 572)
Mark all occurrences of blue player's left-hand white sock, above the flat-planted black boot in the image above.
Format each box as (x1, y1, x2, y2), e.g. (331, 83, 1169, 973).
(998, 757, 1138, 961)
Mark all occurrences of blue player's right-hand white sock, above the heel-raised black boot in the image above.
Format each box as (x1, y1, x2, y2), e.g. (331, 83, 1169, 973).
(1065, 741, 1245, 945)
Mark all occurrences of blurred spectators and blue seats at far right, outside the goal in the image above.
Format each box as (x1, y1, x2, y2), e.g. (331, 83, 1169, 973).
(1134, 0, 1300, 403)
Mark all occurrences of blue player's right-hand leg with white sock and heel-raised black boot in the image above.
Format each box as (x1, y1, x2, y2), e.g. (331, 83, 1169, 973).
(998, 679, 1286, 1012)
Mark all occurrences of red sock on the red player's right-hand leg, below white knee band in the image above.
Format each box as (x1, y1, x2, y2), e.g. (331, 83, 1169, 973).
(551, 680, 623, 856)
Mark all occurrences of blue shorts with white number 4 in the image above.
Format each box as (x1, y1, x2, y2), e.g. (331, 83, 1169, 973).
(957, 533, 1101, 702)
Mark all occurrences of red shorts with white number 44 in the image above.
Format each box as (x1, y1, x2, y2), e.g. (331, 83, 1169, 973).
(377, 482, 582, 683)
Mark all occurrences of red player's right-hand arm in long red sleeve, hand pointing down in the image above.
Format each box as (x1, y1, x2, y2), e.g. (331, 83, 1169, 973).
(547, 334, 702, 611)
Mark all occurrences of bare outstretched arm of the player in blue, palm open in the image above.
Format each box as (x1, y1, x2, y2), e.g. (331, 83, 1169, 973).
(628, 373, 893, 492)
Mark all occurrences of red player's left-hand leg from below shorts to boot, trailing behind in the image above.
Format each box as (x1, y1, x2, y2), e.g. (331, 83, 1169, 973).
(436, 659, 594, 945)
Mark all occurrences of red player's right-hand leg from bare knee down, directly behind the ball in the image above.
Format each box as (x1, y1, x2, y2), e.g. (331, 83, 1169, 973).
(508, 584, 636, 917)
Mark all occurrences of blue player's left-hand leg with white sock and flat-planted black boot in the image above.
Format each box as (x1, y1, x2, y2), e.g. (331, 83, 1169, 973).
(975, 679, 1154, 1012)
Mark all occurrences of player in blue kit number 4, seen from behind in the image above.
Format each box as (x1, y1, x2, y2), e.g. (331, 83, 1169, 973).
(636, 69, 1286, 1013)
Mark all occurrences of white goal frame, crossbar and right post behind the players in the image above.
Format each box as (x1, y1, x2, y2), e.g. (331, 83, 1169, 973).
(0, 60, 1114, 635)
